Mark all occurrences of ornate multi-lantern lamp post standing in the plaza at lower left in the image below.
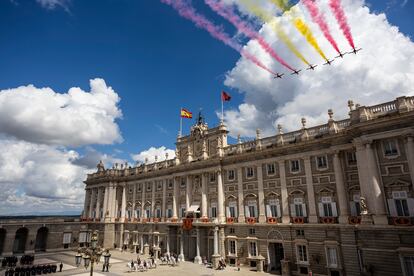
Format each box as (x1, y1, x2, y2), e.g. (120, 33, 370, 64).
(75, 231, 110, 276)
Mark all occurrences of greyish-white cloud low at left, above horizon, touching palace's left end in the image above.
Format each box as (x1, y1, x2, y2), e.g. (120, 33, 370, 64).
(0, 137, 91, 215)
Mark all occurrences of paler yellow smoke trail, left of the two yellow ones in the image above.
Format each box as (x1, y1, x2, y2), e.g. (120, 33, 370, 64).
(240, 0, 310, 65)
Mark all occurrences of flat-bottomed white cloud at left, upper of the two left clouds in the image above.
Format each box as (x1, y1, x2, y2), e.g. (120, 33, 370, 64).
(0, 79, 122, 146)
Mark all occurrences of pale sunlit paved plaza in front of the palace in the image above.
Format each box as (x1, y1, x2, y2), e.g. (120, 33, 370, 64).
(4, 250, 257, 276)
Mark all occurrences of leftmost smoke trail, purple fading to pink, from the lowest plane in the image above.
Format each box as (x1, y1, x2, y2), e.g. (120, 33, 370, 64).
(161, 0, 276, 75)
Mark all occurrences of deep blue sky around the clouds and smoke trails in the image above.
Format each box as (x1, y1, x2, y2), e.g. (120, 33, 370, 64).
(0, 0, 414, 215)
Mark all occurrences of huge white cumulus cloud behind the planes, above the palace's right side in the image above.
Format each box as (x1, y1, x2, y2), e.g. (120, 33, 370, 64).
(225, 0, 414, 136)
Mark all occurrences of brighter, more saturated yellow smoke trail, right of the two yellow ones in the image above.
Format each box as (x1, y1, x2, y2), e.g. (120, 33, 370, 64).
(269, 0, 327, 60)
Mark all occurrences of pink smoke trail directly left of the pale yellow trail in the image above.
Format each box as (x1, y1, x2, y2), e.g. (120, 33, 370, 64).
(204, 0, 294, 71)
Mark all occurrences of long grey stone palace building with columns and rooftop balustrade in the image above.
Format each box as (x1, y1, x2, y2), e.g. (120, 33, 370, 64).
(0, 97, 414, 276)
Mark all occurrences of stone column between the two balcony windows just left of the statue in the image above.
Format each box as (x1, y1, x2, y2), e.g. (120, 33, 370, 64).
(333, 152, 349, 223)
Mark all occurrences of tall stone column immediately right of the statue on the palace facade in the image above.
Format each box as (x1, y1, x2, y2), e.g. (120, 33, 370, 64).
(365, 143, 388, 225)
